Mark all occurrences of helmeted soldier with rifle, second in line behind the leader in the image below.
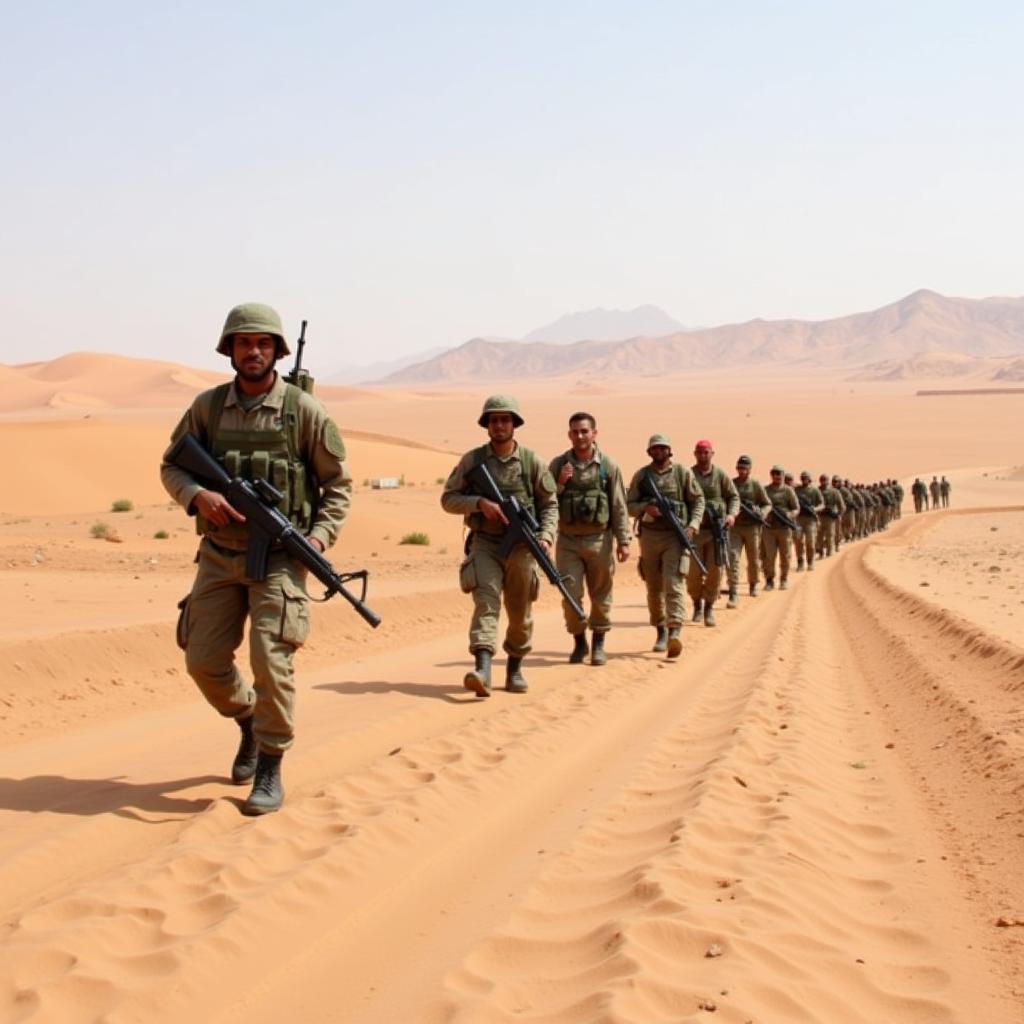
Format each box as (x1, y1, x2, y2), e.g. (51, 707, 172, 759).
(441, 394, 558, 697)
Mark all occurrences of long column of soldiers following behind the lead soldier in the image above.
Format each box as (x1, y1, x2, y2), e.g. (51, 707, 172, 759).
(441, 395, 903, 697)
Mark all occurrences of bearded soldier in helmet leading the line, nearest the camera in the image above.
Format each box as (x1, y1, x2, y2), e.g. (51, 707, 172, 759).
(160, 302, 352, 814)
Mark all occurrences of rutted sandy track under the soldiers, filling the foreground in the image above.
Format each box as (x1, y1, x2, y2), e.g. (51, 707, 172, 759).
(0, 519, 1024, 1024)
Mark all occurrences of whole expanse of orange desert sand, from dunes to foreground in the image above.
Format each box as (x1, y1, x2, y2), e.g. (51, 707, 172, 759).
(0, 353, 1024, 1024)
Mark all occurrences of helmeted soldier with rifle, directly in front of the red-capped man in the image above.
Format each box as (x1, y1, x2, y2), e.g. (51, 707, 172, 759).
(626, 434, 705, 657)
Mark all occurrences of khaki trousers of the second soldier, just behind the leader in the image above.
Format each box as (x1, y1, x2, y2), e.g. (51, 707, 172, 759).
(459, 534, 541, 657)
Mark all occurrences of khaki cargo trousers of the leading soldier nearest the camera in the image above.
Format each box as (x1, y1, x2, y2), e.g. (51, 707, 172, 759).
(178, 540, 309, 753)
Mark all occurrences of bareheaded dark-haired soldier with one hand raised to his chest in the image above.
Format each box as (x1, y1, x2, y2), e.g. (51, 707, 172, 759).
(550, 413, 630, 665)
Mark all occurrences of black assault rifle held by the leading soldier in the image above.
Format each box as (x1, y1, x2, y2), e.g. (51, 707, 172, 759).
(167, 433, 381, 629)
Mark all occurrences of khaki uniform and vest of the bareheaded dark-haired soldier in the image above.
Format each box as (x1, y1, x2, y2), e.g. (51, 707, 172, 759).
(549, 444, 630, 636)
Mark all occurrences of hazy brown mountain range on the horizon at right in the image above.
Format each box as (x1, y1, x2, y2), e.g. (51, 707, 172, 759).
(382, 289, 1024, 384)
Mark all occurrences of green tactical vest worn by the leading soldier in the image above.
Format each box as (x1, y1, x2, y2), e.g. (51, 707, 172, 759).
(196, 384, 317, 543)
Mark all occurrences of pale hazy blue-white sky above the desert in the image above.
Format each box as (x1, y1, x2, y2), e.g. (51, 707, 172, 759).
(0, 0, 1024, 369)
